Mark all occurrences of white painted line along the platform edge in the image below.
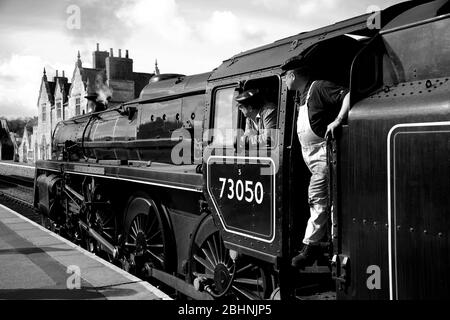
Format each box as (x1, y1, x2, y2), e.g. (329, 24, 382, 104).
(0, 204, 173, 300)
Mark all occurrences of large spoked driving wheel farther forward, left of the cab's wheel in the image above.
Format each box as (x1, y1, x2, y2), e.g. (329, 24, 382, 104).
(123, 195, 170, 276)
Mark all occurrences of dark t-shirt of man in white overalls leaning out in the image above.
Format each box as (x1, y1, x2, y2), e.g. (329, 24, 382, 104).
(301, 80, 349, 138)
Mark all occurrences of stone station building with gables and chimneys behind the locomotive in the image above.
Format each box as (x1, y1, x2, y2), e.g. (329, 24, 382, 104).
(19, 44, 159, 162)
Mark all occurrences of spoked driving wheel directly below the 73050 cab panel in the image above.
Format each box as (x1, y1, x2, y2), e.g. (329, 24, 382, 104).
(191, 215, 274, 300)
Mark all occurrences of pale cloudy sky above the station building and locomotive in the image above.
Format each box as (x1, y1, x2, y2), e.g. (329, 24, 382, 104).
(0, 0, 402, 118)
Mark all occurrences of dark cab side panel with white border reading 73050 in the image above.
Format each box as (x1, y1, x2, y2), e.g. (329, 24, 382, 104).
(207, 156, 275, 242)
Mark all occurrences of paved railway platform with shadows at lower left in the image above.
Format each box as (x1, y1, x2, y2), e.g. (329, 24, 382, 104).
(0, 204, 171, 300)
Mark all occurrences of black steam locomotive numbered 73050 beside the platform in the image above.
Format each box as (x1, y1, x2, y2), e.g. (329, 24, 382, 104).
(35, 0, 450, 299)
